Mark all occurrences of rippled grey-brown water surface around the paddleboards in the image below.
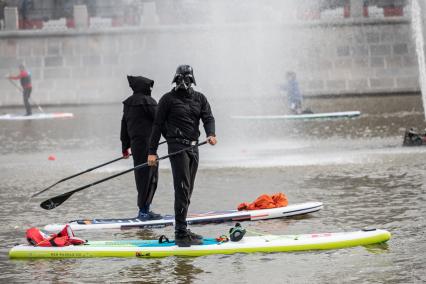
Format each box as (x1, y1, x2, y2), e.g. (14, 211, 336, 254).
(0, 96, 426, 283)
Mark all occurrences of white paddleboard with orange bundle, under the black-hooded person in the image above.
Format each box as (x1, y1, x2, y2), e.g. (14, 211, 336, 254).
(44, 202, 323, 232)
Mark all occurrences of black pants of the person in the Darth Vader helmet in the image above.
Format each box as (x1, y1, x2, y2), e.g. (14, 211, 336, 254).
(169, 143, 198, 234)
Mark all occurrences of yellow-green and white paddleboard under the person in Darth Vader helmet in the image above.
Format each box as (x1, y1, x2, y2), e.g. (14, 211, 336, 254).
(9, 229, 391, 259)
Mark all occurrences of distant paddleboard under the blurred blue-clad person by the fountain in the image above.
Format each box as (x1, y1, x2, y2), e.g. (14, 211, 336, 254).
(231, 111, 361, 120)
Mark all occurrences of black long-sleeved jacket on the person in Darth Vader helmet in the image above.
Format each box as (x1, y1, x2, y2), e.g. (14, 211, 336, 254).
(149, 88, 215, 155)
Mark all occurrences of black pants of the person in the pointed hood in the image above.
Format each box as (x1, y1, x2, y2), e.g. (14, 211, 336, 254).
(131, 141, 158, 210)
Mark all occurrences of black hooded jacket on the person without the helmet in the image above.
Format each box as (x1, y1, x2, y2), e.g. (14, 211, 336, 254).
(120, 76, 157, 152)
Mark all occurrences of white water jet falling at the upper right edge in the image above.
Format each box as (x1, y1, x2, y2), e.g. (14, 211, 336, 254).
(411, 0, 426, 119)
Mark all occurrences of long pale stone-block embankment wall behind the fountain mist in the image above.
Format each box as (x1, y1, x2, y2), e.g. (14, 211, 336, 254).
(0, 17, 419, 105)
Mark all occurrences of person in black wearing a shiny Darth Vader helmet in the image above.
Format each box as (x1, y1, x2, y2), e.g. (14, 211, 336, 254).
(148, 65, 217, 247)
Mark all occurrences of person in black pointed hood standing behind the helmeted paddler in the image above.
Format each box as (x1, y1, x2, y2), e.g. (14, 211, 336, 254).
(120, 76, 162, 221)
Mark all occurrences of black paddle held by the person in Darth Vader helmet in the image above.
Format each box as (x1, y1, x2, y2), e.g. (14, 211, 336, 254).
(40, 141, 207, 210)
